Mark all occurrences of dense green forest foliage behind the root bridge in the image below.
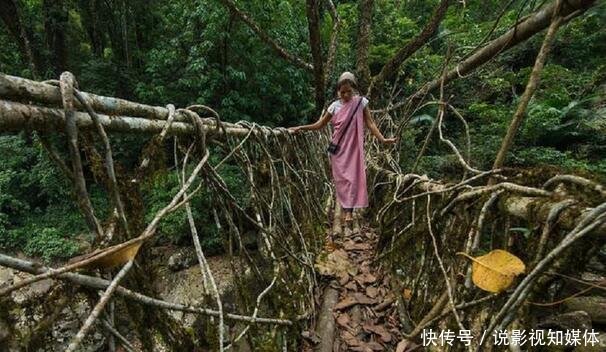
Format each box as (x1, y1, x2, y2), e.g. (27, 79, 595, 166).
(0, 0, 606, 259)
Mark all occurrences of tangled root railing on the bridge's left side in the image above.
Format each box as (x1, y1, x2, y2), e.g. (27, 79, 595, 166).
(0, 72, 332, 351)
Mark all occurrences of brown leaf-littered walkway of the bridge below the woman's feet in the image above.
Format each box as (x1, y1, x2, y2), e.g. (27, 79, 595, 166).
(303, 209, 419, 352)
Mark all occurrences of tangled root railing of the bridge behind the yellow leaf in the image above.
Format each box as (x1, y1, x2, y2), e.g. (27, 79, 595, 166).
(373, 165, 606, 347)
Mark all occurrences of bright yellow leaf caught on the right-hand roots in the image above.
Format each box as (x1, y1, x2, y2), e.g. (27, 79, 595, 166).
(457, 249, 526, 293)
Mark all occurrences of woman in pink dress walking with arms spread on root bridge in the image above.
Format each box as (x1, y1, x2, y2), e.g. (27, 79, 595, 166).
(290, 72, 396, 223)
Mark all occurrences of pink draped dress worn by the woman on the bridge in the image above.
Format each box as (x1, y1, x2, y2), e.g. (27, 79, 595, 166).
(329, 96, 368, 208)
